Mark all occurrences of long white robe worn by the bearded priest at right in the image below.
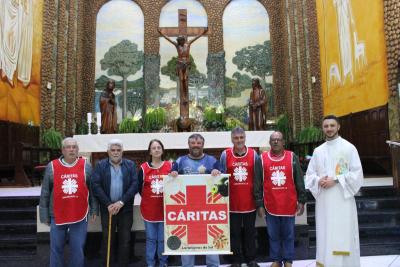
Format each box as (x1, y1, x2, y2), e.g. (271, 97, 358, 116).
(305, 137, 363, 267)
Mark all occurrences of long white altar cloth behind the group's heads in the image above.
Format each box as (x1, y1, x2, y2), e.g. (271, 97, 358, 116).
(74, 131, 272, 153)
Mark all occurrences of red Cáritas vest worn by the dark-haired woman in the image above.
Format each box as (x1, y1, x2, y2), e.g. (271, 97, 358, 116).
(140, 161, 172, 222)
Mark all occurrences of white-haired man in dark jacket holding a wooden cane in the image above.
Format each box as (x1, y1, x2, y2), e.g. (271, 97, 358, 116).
(93, 139, 138, 266)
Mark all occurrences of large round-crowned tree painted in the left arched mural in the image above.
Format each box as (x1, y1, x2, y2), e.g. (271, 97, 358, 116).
(100, 40, 143, 118)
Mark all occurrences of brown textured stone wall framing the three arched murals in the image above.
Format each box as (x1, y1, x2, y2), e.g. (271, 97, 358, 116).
(46, 0, 400, 140)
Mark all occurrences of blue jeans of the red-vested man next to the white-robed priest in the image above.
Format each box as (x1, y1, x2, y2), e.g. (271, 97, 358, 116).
(265, 212, 294, 263)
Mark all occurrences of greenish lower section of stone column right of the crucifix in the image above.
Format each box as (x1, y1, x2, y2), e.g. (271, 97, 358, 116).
(207, 51, 226, 106)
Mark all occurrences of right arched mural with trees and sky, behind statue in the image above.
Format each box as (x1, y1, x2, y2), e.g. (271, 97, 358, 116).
(223, 0, 273, 125)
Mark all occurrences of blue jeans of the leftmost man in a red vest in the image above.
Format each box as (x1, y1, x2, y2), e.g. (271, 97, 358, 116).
(50, 218, 87, 267)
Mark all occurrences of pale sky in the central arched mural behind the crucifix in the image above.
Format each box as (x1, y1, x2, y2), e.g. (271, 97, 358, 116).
(159, 0, 208, 88)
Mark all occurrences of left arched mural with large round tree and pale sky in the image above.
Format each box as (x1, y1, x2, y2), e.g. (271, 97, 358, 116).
(95, 0, 144, 122)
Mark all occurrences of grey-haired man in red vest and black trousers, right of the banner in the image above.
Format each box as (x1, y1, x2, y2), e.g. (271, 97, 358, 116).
(220, 127, 261, 267)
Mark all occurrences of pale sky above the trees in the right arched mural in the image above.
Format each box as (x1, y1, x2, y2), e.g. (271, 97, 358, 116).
(223, 0, 270, 77)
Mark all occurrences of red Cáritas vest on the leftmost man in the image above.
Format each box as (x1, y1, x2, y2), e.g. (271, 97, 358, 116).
(52, 158, 89, 225)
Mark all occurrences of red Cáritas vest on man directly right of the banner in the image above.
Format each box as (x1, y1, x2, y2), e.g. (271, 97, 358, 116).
(225, 148, 256, 213)
